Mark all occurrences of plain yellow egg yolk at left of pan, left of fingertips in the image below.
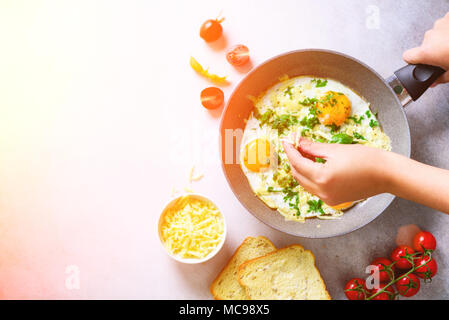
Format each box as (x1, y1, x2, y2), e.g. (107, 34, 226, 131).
(243, 139, 271, 172)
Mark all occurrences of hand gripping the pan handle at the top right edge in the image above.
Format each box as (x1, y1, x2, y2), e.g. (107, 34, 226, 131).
(402, 12, 449, 86)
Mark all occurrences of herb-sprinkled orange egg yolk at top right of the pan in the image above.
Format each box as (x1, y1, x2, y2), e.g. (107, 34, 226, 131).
(316, 91, 351, 126)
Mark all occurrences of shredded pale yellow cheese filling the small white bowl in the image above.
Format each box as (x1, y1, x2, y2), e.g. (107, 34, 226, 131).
(161, 196, 224, 259)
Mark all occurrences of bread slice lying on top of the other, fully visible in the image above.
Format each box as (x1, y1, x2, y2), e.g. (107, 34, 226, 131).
(238, 244, 331, 300)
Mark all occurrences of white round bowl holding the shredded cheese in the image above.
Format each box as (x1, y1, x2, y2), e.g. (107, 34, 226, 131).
(158, 193, 227, 264)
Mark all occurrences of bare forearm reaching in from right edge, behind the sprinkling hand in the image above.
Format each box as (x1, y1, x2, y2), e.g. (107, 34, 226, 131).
(385, 153, 449, 213)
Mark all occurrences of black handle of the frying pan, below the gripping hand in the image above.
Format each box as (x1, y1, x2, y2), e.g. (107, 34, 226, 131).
(394, 64, 446, 101)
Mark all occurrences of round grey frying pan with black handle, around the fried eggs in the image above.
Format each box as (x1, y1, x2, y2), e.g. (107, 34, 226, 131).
(220, 49, 444, 238)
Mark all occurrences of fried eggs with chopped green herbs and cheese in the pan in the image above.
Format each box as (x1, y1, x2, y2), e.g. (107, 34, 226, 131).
(240, 76, 391, 222)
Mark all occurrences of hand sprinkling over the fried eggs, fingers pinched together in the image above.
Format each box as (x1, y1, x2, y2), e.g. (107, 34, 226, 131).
(282, 138, 390, 206)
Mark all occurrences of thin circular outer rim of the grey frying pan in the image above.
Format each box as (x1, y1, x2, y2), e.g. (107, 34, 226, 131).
(218, 48, 411, 239)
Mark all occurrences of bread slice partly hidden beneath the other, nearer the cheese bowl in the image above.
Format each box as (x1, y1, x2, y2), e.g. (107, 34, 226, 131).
(210, 236, 276, 300)
